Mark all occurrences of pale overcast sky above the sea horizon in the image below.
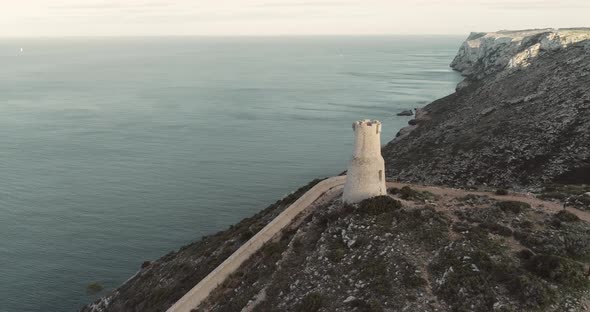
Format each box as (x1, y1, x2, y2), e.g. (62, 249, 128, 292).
(0, 0, 590, 37)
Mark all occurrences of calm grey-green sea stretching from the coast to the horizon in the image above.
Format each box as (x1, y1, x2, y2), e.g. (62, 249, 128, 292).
(0, 37, 463, 312)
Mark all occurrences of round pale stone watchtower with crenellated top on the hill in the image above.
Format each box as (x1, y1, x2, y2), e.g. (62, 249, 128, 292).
(342, 120, 387, 204)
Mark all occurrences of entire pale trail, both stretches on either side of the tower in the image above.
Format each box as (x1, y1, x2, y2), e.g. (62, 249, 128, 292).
(167, 176, 590, 312)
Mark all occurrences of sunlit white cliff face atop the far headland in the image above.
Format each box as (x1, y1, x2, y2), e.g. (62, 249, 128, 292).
(451, 28, 590, 83)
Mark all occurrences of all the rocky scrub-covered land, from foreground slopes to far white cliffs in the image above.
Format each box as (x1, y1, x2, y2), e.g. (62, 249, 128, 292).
(81, 29, 590, 312)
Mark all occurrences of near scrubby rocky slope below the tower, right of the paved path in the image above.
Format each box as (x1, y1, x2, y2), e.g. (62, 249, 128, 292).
(197, 187, 590, 312)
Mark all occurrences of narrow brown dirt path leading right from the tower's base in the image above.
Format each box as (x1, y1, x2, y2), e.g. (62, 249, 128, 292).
(387, 182, 590, 222)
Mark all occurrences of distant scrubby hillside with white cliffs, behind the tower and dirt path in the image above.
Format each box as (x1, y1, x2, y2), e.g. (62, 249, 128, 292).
(383, 30, 590, 188)
